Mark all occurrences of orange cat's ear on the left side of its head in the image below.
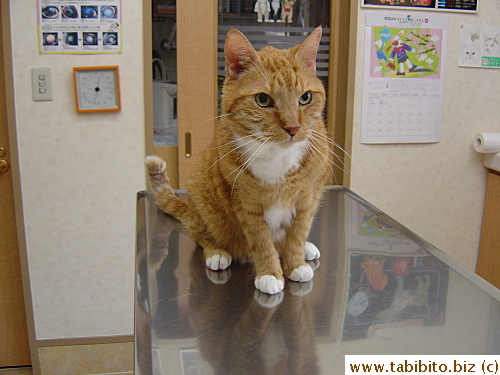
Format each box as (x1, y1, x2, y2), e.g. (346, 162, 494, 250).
(224, 29, 258, 79)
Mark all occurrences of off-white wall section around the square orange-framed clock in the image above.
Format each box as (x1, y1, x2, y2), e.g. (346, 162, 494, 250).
(10, 0, 145, 340)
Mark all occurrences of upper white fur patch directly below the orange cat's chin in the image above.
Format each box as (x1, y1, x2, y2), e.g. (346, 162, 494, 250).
(237, 140, 308, 185)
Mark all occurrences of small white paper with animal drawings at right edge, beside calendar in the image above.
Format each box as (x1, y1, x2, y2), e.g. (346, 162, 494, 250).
(458, 25, 500, 68)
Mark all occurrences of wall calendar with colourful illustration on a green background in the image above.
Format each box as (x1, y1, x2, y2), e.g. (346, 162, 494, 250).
(361, 12, 448, 144)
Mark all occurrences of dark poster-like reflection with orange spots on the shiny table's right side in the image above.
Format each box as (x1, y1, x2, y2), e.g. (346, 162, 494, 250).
(342, 252, 448, 341)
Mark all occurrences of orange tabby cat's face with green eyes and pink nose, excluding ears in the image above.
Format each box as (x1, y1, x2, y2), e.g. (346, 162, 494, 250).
(222, 27, 325, 147)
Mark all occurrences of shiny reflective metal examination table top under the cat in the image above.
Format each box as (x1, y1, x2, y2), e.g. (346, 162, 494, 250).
(135, 187, 500, 375)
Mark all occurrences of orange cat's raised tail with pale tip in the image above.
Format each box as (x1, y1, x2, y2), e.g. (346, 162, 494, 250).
(144, 155, 188, 223)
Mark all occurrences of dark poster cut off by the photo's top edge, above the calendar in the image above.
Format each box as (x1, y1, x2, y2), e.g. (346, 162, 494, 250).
(361, 0, 479, 13)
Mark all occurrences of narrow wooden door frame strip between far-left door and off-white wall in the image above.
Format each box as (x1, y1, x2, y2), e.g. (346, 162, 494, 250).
(0, 0, 40, 374)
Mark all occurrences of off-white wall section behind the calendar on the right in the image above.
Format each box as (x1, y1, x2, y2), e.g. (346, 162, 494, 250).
(350, 0, 500, 270)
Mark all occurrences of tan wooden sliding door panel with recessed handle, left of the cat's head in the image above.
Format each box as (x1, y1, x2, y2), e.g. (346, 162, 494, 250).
(176, 0, 218, 189)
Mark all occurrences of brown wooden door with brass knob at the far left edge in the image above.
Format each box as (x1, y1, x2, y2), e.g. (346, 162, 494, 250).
(0, 1, 31, 368)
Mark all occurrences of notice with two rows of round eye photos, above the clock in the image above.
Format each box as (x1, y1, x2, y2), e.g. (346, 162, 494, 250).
(37, 0, 122, 54)
